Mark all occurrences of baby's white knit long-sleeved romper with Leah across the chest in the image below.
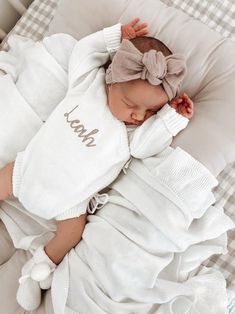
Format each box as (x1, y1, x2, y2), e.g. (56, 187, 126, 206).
(13, 24, 188, 220)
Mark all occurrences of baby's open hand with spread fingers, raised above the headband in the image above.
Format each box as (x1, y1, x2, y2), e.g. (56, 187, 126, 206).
(121, 17, 148, 40)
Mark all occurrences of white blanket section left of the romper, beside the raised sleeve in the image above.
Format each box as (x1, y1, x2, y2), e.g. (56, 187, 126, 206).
(0, 34, 76, 167)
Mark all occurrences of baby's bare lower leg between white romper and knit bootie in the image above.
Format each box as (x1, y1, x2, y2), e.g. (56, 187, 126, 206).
(45, 214, 87, 264)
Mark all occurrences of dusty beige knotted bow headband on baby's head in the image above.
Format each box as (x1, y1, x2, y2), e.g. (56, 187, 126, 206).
(105, 39, 186, 100)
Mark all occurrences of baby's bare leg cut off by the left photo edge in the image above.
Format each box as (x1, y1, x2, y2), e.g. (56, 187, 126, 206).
(0, 162, 14, 201)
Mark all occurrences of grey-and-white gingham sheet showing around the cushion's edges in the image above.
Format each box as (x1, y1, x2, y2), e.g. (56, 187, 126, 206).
(0, 0, 235, 314)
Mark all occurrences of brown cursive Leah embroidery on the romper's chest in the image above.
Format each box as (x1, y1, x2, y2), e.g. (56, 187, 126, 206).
(64, 105, 99, 147)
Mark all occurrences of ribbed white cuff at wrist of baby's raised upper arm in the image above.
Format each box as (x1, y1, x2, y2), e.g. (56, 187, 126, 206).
(103, 23, 122, 53)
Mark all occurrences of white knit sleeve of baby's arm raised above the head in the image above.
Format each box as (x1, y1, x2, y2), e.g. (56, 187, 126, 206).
(69, 23, 121, 88)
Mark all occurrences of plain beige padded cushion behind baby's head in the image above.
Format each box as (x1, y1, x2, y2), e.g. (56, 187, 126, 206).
(49, 0, 235, 176)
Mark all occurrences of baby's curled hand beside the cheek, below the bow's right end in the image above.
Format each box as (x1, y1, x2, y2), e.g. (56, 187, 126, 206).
(170, 93, 193, 119)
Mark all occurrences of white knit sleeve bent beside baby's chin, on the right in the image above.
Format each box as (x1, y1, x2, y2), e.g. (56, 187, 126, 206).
(130, 104, 189, 159)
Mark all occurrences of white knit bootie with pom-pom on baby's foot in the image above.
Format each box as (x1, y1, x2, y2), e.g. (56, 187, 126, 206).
(16, 246, 56, 311)
